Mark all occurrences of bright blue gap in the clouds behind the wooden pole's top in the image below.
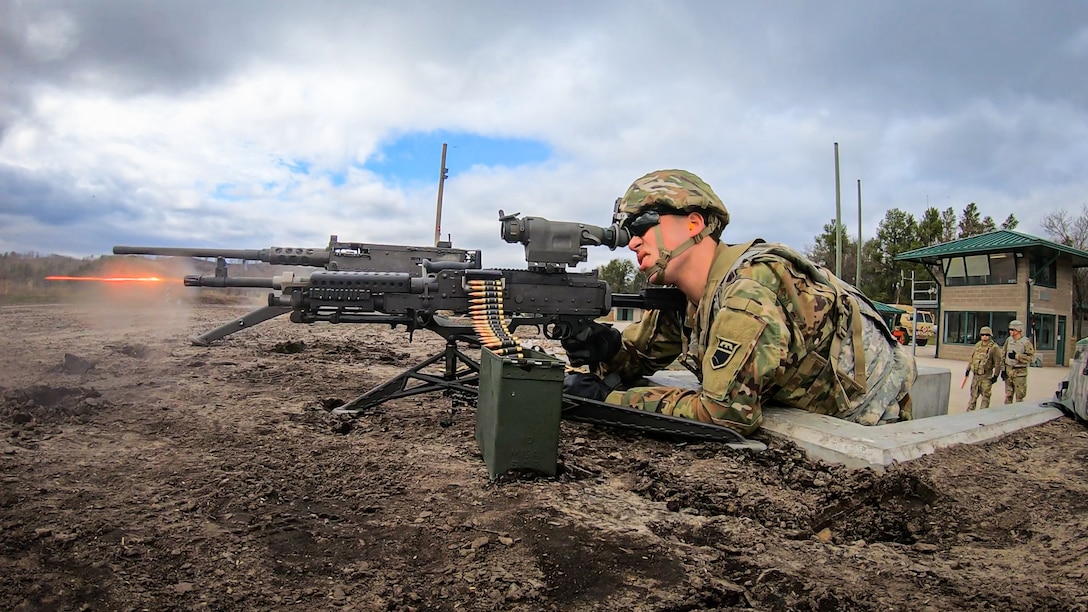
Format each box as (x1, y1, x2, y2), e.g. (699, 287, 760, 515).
(362, 131, 552, 184)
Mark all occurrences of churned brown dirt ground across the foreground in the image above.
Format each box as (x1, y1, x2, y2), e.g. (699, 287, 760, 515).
(0, 294, 1088, 611)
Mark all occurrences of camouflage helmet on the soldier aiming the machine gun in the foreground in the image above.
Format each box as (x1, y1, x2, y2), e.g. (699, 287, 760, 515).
(616, 170, 729, 238)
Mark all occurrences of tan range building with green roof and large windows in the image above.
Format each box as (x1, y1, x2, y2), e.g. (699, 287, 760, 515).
(895, 230, 1088, 366)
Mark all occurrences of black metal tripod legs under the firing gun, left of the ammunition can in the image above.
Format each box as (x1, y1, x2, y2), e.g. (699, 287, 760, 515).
(333, 338, 480, 415)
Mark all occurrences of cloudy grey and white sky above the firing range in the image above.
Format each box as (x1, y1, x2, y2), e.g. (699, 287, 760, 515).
(0, 0, 1088, 267)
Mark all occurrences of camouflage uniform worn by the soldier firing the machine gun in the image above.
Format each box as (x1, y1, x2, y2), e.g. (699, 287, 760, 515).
(598, 171, 917, 433)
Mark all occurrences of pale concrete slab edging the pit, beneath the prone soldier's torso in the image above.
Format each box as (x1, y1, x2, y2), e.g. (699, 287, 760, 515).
(763, 403, 1063, 472)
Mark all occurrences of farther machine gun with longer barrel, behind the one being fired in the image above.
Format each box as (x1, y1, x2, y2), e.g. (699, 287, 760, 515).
(113, 235, 480, 346)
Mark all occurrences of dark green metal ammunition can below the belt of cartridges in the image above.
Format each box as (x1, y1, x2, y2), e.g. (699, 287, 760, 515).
(477, 348, 566, 478)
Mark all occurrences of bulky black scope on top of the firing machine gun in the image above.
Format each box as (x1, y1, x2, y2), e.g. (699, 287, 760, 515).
(498, 210, 631, 270)
